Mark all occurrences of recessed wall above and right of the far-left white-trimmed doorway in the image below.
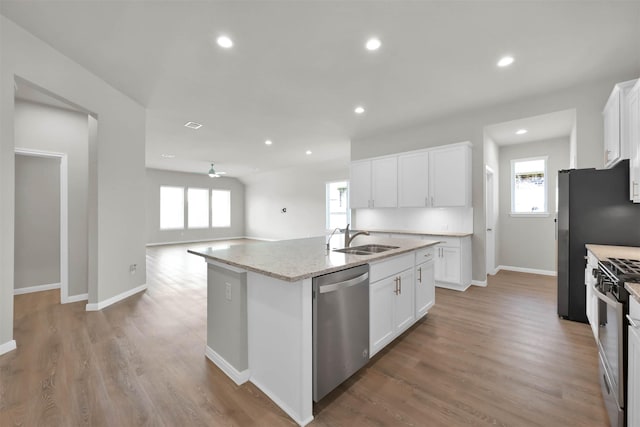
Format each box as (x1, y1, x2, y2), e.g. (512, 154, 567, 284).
(14, 100, 89, 296)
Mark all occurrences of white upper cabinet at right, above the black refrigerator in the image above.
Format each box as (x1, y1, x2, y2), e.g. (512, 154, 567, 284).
(602, 80, 636, 168)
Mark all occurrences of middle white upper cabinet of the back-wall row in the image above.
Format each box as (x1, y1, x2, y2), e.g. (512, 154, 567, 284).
(398, 151, 431, 208)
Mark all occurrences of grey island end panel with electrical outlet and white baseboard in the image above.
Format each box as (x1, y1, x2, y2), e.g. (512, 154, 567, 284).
(206, 262, 249, 384)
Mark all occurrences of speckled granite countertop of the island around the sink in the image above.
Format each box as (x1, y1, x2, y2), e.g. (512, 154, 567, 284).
(188, 234, 439, 282)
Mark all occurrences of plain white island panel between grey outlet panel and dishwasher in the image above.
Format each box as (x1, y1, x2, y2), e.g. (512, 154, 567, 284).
(247, 272, 313, 425)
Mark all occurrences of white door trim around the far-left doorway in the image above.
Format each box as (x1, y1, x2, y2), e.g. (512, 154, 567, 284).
(15, 147, 72, 304)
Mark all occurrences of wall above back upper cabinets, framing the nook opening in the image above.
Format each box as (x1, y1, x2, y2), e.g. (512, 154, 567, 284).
(351, 69, 640, 281)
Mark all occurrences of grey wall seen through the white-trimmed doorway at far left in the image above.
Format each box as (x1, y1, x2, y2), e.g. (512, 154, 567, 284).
(14, 155, 60, 289)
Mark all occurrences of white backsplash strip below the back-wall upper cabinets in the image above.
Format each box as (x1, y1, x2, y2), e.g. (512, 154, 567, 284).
(351, 208, 473, 233)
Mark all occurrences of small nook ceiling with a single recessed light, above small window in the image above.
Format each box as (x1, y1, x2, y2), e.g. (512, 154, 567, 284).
(484, 109, 576, 145)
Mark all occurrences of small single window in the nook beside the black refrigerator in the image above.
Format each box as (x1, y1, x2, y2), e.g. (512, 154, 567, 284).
(511, 157, 547, 215)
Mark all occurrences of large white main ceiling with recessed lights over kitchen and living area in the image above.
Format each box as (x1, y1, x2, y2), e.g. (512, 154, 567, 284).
(0, 0, 640, 178)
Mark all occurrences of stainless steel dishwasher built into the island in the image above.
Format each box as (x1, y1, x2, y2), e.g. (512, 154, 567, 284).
(313, 265, 369, 402)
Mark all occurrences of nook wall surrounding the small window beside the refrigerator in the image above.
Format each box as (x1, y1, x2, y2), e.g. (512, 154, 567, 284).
(498, 137, 570, 273)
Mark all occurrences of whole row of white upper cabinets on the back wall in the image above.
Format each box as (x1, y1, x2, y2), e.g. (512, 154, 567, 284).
(350, 143, 471, 209)
